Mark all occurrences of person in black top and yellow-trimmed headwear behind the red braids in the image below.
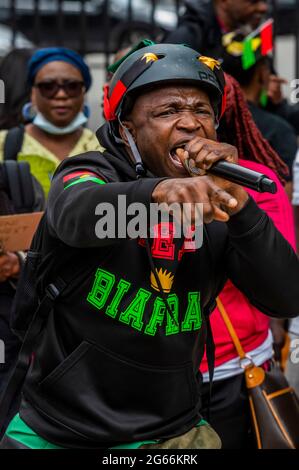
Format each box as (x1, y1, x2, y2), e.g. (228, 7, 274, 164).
(222, 28, 297, 199)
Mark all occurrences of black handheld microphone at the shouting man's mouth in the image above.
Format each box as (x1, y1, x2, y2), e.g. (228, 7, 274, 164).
(208, 161, 277, 194)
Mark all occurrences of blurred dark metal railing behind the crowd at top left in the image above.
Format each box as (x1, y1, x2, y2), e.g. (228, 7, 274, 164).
(0, 0, 182, 54)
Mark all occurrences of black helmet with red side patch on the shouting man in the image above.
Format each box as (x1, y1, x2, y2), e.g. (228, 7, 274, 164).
(104, 44, 225, 121)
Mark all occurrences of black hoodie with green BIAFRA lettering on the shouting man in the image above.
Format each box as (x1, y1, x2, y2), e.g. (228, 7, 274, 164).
(21, 121, 299, 448)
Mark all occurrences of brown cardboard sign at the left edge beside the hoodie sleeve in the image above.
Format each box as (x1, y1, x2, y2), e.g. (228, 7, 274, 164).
(0, 212, 43, 252)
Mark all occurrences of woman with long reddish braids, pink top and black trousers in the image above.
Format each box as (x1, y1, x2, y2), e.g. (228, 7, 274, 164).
(201, 75, 295, 449)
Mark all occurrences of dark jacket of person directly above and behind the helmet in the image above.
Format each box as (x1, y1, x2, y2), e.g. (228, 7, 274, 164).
(164, 0, 223, 59)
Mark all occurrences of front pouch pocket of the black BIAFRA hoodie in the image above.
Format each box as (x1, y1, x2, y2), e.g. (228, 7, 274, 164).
(40, 341, 198, 442)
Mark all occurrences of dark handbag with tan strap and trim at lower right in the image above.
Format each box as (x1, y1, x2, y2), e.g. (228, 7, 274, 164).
(217, 297, 299, 449)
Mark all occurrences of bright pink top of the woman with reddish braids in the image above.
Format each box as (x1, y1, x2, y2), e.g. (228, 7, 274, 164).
(200, 160, 295, 372)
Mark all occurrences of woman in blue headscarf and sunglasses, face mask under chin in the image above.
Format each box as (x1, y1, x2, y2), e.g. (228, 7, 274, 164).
(0, 47, 100, 195)
